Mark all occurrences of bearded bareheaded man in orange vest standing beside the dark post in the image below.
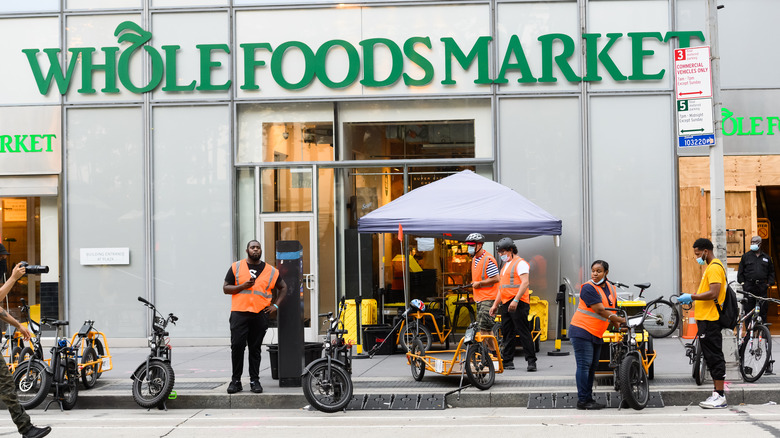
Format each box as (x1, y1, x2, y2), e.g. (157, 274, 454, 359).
(222, 240, 287, 394)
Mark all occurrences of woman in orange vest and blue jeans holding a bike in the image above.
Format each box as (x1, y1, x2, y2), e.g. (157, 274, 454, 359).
(568, 260, 626, 410)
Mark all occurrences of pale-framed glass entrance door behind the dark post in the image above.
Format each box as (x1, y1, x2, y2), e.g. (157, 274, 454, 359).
(257, 213, 319, 343)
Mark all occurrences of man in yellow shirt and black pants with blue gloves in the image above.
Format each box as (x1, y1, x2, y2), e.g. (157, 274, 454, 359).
(678, 238, 728, 409)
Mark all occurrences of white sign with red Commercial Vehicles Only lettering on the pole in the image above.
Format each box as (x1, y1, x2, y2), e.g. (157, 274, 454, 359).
(674, 46, 712, 99)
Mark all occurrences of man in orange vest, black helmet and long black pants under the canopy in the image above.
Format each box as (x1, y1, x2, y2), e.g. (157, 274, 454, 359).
(490, 237, 536, 371)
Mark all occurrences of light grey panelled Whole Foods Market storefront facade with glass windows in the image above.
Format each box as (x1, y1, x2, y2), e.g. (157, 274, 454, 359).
(0, 0, 780, 342)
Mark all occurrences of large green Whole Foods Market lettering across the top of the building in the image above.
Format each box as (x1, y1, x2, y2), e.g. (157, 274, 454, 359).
(22, 21, 704, 95)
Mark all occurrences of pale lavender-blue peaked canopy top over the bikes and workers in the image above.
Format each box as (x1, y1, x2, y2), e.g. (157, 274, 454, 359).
(358, 170, 561, 241)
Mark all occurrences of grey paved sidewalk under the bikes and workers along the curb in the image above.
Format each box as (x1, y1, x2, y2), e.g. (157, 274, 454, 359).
(67, 338, 780, 409)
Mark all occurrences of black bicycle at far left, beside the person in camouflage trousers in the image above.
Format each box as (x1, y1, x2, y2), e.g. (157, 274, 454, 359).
(13, 318, 80, 410)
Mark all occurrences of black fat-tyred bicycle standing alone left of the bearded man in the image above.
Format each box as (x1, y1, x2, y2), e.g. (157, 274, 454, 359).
(130, 297, 179, 409)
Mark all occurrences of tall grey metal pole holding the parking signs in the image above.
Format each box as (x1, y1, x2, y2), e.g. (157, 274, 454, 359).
(707, 0, 727, 261)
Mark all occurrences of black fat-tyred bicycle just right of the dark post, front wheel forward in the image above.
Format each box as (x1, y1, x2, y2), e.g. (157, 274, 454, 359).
(302, 297, 353, 412)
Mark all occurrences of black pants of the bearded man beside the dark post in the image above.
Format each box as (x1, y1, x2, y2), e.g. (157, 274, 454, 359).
(230, 312, 268, 381)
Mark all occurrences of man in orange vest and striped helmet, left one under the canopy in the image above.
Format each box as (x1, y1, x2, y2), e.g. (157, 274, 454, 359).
(465, 233, 498, 335)
